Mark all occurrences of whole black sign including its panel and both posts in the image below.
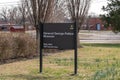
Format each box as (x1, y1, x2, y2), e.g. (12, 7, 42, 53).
(40, 22, 77, 74)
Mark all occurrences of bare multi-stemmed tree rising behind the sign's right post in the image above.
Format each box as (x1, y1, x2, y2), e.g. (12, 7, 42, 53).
(66, 0, 91, 46)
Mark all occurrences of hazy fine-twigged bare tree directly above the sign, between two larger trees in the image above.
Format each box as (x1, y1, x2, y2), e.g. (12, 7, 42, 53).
(50, 0, 66, 23)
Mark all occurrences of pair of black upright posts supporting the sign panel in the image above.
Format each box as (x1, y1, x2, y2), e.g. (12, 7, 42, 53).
(39, 22, 78, 74)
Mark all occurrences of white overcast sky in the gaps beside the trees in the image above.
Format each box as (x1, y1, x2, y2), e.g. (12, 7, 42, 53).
(0, 0, 107, 15)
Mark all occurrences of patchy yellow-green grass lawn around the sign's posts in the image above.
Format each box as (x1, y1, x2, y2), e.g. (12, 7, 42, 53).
(0, 44, 120, 80)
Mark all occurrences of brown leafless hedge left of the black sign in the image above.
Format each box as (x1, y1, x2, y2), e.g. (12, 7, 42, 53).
(0, 33, 37, 62)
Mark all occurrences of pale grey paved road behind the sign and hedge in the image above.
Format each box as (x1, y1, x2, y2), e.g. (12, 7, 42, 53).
(26, 31, 120, 43)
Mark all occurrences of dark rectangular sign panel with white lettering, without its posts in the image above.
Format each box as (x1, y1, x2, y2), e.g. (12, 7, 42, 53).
(43, 23, 74, 49)
